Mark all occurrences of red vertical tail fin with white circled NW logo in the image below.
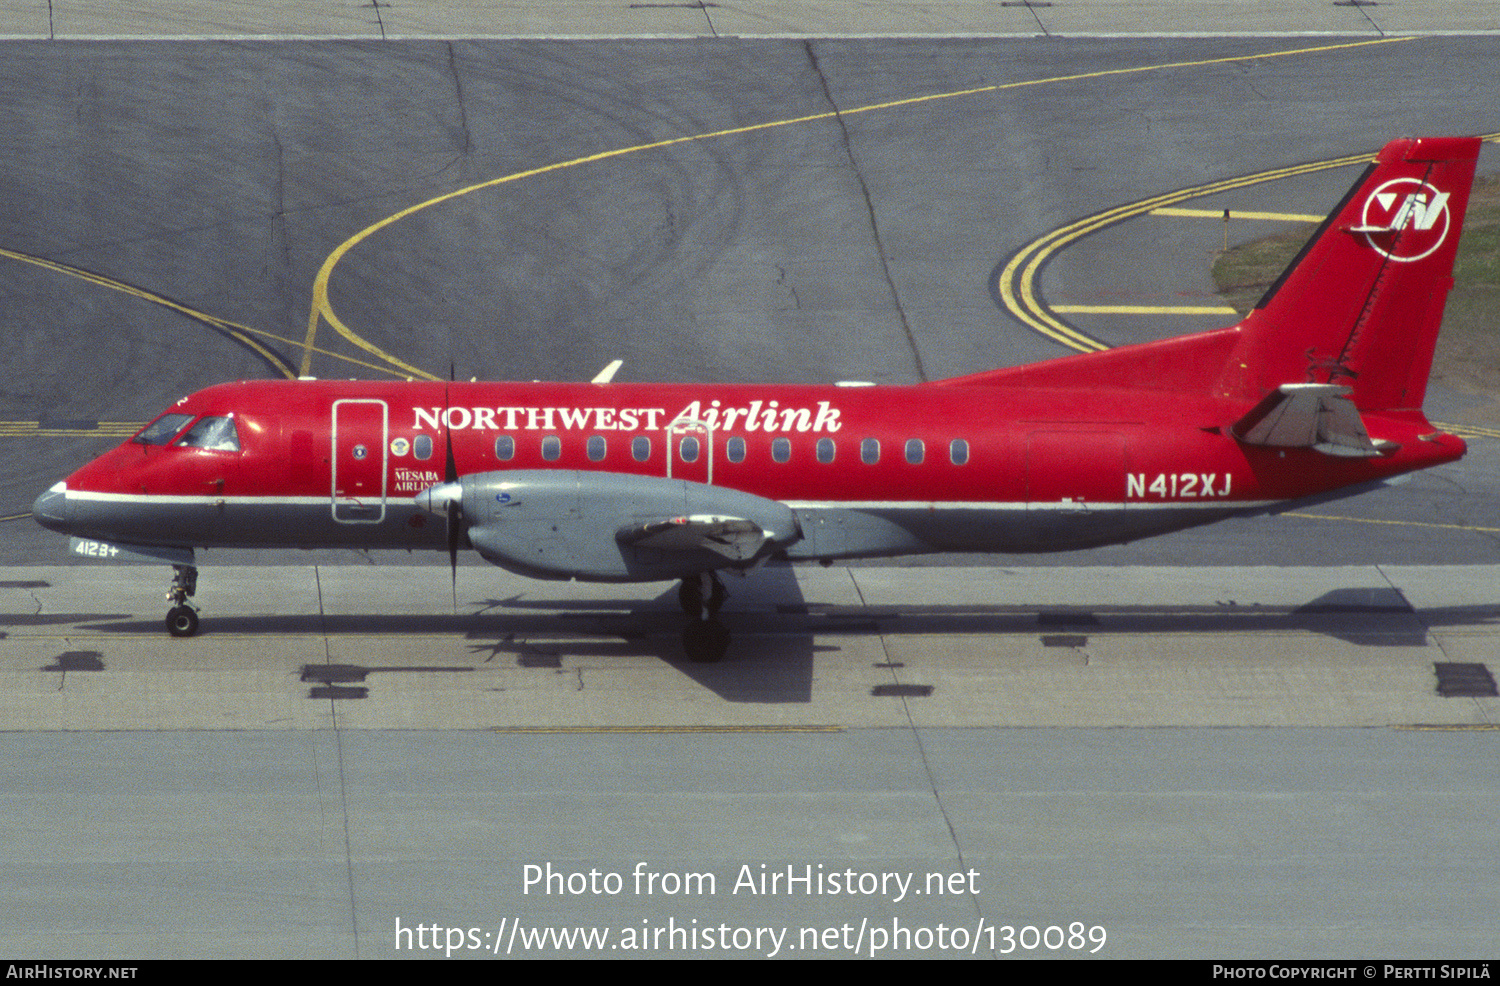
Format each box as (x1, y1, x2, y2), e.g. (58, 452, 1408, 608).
(1220, 137, 1479, 411)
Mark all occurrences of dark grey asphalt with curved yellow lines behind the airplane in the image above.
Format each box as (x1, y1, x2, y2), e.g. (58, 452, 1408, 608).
(0, 36, 1500, 564)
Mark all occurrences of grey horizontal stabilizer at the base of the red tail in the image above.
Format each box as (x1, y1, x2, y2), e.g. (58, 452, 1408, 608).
(1233, 383, 1398, 458)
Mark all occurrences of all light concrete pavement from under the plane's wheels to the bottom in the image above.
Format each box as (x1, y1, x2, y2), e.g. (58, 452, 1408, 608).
(0, 566, 1500, 959)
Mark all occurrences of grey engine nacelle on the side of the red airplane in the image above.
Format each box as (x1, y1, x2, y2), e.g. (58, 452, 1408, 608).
(435, 470, 801, 582)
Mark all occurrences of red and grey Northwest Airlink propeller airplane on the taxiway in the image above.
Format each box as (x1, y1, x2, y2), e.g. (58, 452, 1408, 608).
(33, 138, 1479, 659)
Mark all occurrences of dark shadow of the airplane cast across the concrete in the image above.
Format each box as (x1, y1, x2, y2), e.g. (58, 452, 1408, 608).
(35, 570, 1500, 704)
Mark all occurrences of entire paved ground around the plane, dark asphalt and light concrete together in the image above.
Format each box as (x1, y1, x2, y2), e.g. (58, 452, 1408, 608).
(0, 0, 1500, 957)
